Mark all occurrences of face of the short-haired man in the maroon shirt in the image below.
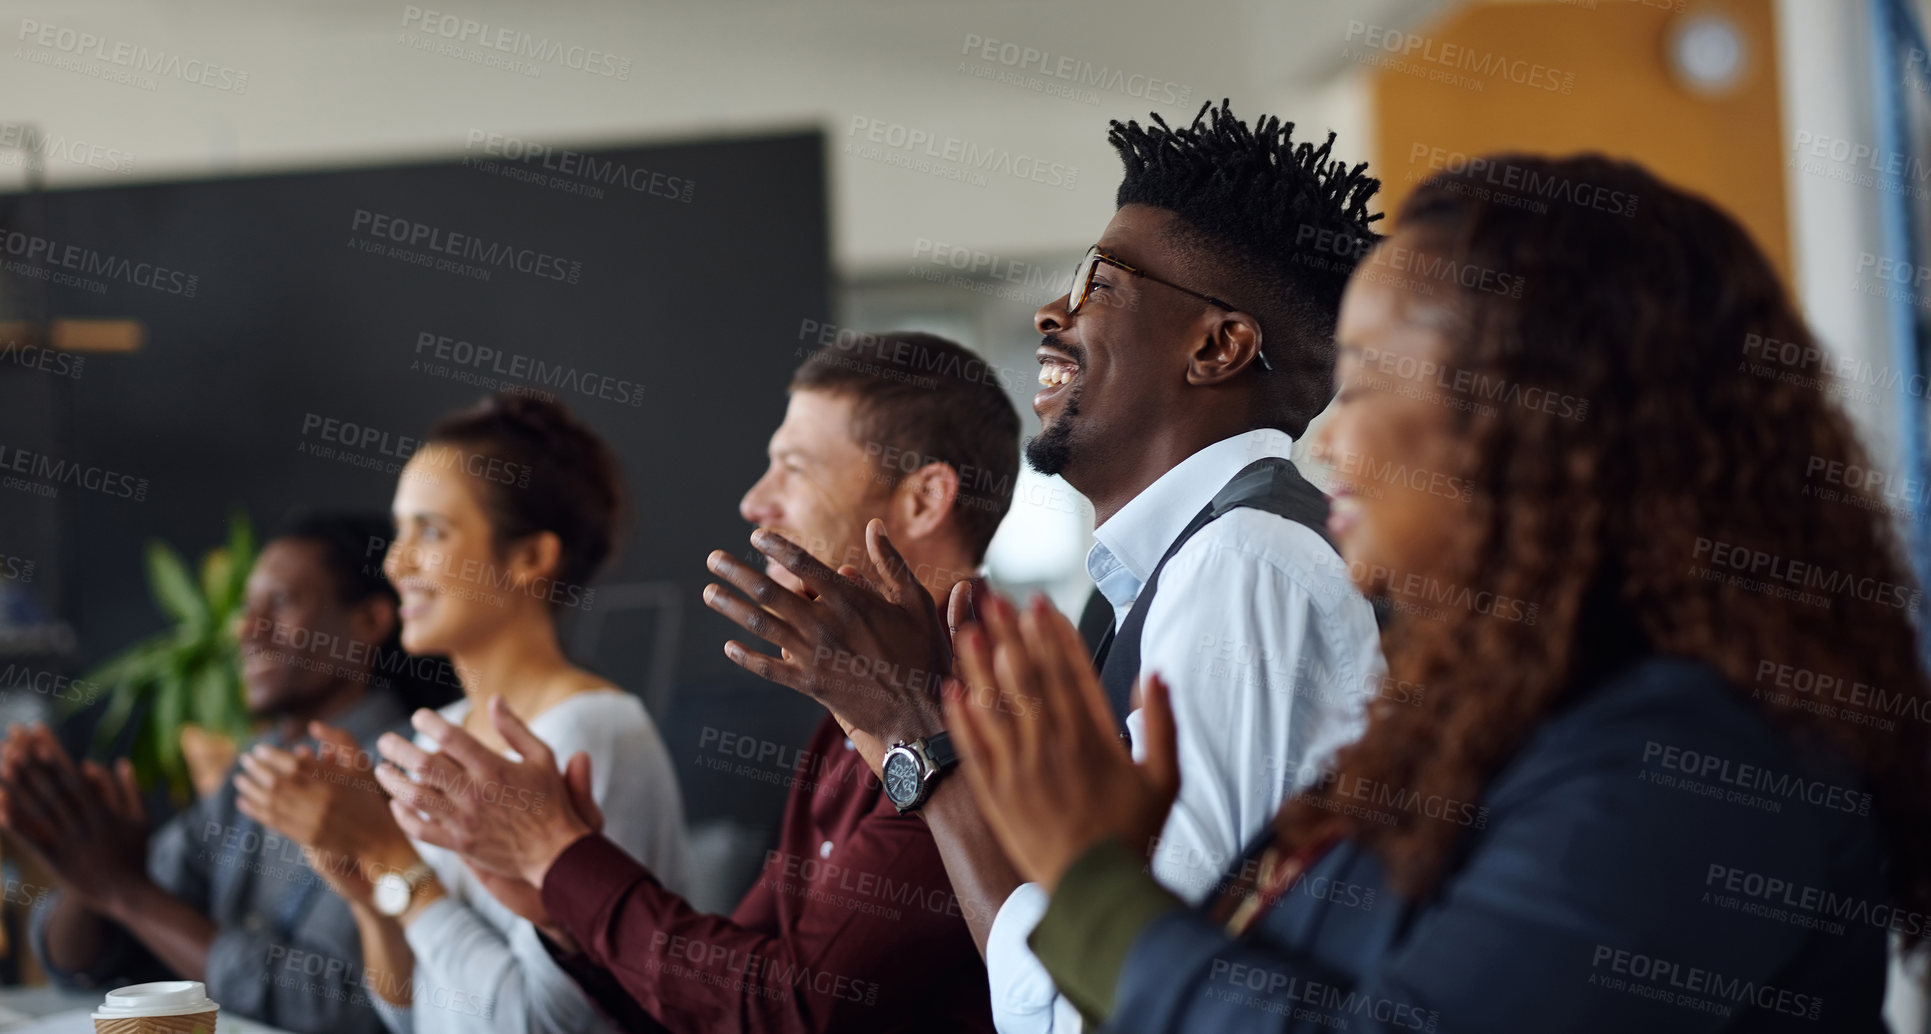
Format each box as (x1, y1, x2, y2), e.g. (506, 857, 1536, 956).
(738, 390, 892, 591)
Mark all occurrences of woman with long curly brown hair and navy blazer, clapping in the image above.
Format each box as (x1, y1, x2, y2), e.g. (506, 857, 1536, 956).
(948, 155, 1931, 1034)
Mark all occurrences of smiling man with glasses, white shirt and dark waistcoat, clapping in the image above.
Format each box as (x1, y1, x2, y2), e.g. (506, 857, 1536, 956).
(707, 102, 1385, 1034)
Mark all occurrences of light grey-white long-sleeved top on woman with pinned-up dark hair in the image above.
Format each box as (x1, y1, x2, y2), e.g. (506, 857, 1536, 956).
(375, 688, 686, 1034)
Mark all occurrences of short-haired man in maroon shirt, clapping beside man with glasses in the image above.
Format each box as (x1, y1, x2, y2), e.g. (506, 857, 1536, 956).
(384, 334, 1020, 1032)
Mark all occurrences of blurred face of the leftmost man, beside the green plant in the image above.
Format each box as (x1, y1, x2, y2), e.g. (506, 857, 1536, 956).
(236, 539, 396, 717)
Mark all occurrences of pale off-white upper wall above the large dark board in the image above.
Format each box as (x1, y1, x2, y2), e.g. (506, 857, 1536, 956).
(0, 0, 1433, 273)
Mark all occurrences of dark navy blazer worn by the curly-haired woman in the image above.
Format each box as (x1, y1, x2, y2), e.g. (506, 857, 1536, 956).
(1112, 657, 1892, 1034)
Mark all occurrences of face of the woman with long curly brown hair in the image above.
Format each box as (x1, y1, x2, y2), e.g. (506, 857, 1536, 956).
(1313, 234, 1469, 593)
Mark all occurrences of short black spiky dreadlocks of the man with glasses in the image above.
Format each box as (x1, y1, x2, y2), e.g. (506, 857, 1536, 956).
(1106, 101, 1381, 437)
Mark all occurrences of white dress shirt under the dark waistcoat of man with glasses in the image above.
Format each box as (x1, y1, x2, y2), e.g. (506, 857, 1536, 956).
(985, 429, 1386, 1034)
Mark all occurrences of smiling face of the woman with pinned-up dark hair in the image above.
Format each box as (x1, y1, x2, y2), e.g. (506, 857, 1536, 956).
(382, 445, 548, 655)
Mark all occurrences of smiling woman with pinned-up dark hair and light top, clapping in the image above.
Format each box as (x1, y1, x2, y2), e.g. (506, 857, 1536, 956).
(239, 394, 686, 1034)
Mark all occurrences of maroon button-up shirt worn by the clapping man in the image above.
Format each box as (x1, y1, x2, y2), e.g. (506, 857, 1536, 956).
(543, 723, 991, 1034)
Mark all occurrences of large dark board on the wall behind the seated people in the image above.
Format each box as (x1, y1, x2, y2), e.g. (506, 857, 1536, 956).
(0, 131, 830, 761)
